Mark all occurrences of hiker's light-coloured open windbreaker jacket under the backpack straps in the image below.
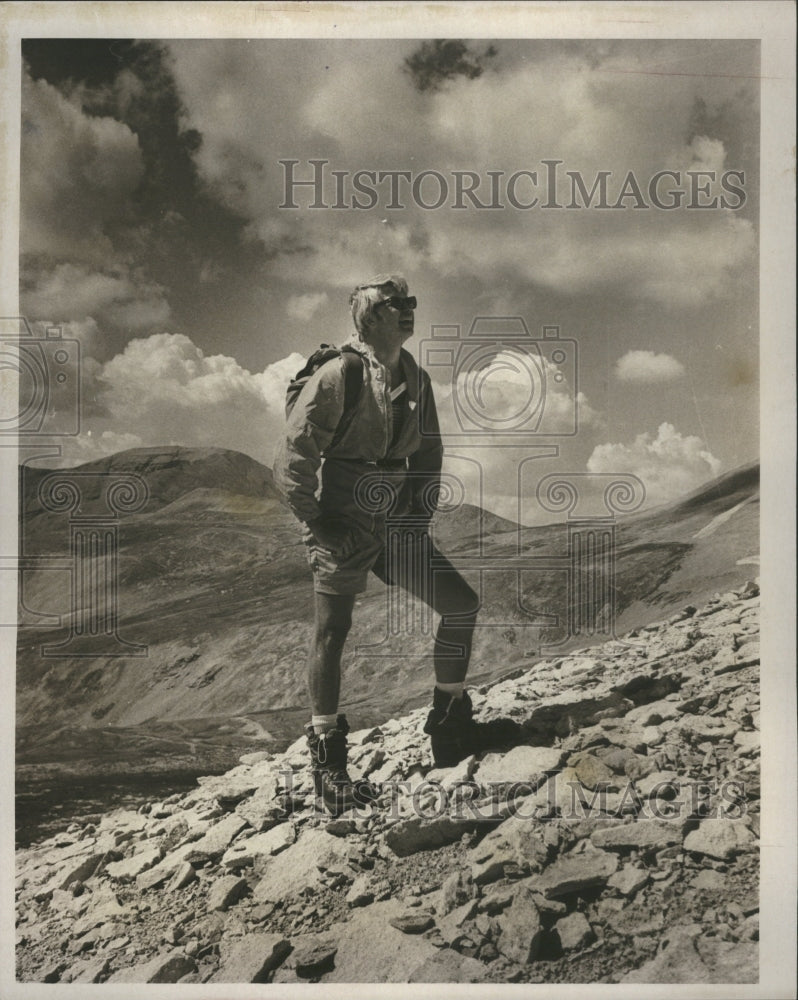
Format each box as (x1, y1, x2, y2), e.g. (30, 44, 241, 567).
(273, 337, 443, 528)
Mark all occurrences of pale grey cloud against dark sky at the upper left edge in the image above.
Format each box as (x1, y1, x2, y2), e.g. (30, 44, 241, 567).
(20, 71, 175, 347)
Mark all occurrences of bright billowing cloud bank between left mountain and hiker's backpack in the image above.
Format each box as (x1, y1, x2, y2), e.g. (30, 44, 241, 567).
(63, 333, 304, 464)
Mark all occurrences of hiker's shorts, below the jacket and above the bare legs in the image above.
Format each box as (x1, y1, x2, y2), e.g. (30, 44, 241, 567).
(303, 521, 432, 595)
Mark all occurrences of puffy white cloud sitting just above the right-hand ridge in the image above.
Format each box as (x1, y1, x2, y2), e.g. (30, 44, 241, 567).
(587, 423, 721, 505)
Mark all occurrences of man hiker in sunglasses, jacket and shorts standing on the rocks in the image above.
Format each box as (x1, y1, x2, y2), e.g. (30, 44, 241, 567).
(274, 275, 479, 814)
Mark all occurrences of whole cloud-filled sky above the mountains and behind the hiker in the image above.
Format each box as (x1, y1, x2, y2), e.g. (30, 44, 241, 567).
(15, 39, 759, 523)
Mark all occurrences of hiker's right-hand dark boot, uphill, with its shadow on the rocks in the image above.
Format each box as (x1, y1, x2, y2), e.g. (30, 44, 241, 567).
(424, 688, 521, 767)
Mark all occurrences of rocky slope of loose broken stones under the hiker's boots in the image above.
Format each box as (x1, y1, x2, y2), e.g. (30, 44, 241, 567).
(16, 582, 760, 984)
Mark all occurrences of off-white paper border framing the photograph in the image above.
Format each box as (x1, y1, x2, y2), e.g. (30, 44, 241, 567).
(0, 0, 798, 1000)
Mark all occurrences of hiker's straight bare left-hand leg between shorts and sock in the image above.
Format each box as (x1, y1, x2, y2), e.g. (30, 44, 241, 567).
(307, 594, 355, 715)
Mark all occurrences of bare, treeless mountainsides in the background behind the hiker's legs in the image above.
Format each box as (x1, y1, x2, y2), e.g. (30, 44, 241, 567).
(17, 447, 759, 766)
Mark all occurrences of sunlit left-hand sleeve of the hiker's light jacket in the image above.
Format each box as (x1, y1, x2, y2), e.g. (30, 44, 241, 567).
(272, 358, 344, 522)
